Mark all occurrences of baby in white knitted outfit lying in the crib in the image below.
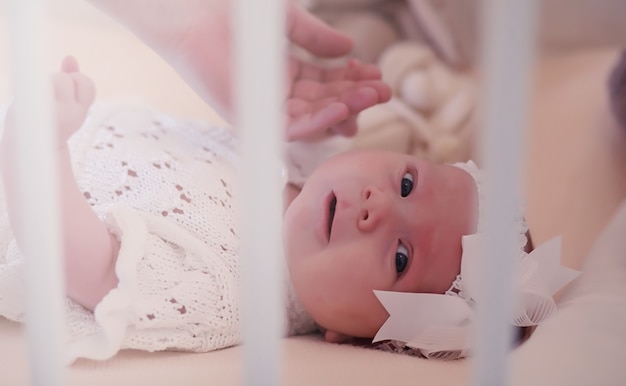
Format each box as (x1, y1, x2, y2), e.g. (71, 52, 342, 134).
(0, 59, 564, 360)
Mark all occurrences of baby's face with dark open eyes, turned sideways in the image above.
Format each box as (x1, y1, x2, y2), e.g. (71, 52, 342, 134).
(284, 151, 478, 337)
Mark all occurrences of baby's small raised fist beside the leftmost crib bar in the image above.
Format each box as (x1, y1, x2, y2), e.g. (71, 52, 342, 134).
(52, 56, 96, 145)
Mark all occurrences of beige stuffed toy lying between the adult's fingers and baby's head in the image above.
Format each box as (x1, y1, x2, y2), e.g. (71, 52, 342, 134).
(353, 41, 476, 162)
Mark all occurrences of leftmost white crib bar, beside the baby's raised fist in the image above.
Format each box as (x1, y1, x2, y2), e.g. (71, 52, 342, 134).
(9, 0, 65, 386)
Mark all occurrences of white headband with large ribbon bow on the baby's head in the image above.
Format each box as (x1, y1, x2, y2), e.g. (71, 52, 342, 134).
(373, 161, 580, 359)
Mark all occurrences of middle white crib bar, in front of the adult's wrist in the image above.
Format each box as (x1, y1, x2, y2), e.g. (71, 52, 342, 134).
(233, 0, 286, 386)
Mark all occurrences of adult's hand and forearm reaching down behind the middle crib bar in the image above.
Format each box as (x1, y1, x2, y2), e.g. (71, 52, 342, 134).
(89, 0, 390, 140)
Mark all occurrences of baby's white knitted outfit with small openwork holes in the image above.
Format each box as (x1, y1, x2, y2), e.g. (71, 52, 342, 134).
(0, 102, 315, 360)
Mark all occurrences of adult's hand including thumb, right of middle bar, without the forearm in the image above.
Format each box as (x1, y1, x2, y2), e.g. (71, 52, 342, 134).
(286, 1, 391, 140)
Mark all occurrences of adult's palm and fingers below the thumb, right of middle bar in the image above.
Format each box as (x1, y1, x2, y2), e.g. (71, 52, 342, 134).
(286, 59, 391, 141)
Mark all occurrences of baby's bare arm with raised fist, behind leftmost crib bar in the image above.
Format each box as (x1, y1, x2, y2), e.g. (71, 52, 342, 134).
(1, 58, 119, 310)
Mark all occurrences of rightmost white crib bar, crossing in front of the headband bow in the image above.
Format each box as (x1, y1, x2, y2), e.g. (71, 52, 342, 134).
(473, 0, 537, 386)
